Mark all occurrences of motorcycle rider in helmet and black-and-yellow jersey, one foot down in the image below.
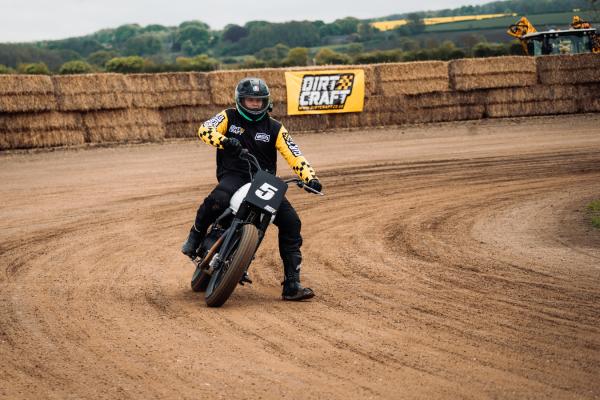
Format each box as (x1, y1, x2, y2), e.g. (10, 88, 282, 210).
(181, 78, 322, 300)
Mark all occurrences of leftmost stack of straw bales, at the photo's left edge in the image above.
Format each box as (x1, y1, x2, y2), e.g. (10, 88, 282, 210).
(0, 75, 84, 150)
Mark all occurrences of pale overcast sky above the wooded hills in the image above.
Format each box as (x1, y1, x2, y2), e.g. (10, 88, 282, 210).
(0, 0, 491, 42)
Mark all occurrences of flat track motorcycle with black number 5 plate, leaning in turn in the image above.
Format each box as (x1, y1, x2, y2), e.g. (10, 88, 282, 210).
(191, 149, 323, 307)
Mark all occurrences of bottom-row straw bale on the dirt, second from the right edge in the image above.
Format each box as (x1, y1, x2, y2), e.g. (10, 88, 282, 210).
(486, 99, 578, 118)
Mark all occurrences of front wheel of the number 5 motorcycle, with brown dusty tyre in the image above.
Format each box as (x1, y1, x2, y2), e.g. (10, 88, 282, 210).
(205, 224, 258, 307)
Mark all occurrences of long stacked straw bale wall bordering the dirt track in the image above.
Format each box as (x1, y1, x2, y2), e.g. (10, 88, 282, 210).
(0, 54, 600, 150)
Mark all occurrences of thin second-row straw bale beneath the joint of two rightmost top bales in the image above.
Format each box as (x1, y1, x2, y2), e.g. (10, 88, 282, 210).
(482, 85, 578, 104)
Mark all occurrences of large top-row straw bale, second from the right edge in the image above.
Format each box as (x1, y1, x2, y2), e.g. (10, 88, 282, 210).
(449, 56, 537, 90)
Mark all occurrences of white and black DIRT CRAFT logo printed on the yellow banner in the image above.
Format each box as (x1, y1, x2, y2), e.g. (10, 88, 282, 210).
(298, 73, 354, 111)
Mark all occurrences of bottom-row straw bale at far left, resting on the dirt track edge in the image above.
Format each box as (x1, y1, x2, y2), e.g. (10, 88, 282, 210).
(0, 128, 85, 150)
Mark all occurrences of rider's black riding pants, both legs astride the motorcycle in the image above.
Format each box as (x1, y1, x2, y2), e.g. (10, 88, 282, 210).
(194, 174, 302, 278)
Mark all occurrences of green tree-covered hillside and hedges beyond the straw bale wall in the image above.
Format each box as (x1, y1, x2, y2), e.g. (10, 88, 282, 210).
(0, 0, 599, 74)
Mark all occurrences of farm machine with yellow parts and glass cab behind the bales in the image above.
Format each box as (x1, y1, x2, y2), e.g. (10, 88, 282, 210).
(507, 16, 600, 56)
